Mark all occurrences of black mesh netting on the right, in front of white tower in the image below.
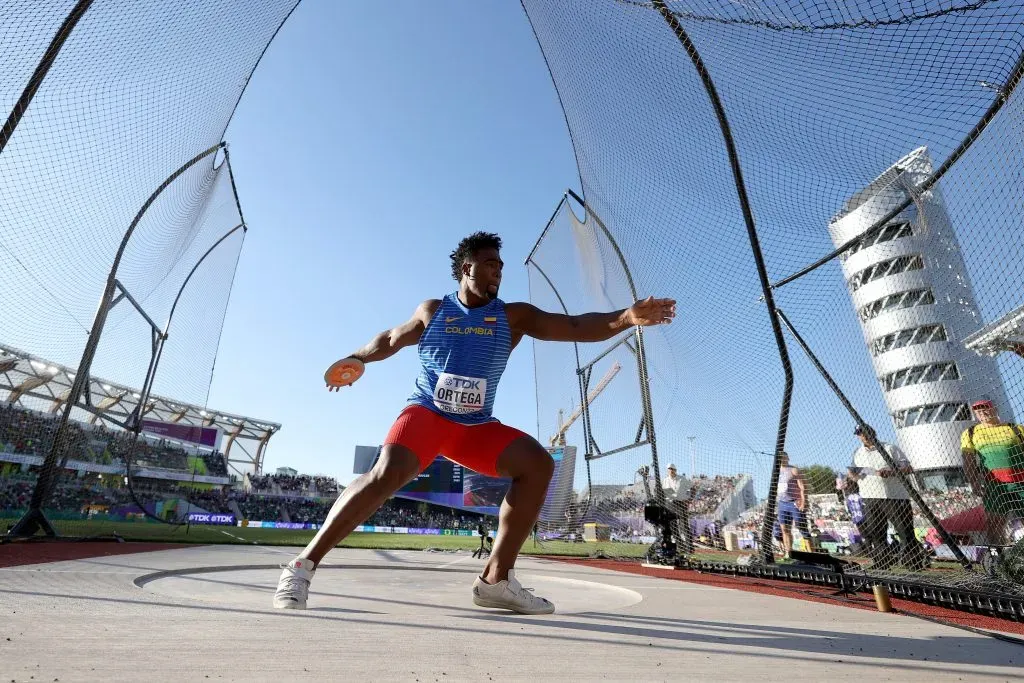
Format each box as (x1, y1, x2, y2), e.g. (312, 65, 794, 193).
(523, 0, 1024, 591)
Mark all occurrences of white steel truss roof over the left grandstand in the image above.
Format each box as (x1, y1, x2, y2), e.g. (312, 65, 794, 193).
(0, 344, 281, 475)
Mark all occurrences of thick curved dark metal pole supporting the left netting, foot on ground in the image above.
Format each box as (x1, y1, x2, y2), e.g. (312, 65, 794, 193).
(9, 142, 226, 537)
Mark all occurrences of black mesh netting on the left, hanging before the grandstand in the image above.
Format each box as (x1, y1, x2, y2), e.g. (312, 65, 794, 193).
(0, 0, 297, 537)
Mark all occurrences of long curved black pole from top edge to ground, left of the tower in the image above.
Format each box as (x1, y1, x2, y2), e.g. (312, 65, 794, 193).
(652, 0, 793, 564)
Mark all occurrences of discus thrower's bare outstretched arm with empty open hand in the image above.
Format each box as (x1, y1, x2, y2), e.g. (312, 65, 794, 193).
(505, 297, 676, 342)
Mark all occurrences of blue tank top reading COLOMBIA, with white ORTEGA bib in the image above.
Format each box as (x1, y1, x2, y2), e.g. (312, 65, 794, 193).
(409, 292, 512, 425)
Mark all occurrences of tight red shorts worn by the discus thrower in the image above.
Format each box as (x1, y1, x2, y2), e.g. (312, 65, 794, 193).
(384, 405, 528, 477)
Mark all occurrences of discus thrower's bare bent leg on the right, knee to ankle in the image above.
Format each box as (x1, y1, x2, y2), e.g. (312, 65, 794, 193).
(480, 436, 555, 584)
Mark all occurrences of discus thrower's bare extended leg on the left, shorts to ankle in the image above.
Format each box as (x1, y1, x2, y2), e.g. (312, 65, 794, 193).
(299, 444, 421, 564)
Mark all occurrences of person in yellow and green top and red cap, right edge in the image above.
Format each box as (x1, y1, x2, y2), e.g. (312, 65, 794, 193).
(961, 400, 1024, 545)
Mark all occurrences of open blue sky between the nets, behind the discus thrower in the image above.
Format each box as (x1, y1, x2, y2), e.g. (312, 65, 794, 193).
(209, 0, 579, 482)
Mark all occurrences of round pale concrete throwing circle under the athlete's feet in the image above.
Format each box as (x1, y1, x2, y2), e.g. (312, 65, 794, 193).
(135, 564, 643, 614)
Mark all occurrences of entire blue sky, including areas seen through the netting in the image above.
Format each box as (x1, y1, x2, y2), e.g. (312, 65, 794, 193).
(0, 0, 1024, 505)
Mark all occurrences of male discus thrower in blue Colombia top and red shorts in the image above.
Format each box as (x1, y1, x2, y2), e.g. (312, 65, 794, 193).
(273, 232, 676, 614)
